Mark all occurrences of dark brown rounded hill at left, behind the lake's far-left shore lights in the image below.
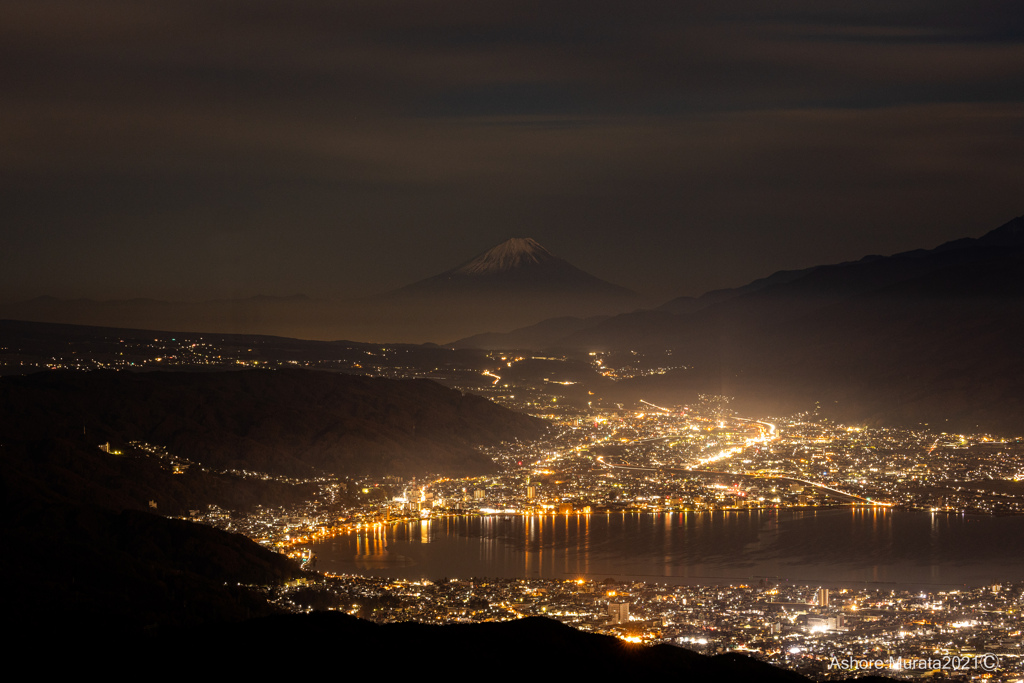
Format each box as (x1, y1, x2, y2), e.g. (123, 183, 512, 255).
(0, 370, 545, 476)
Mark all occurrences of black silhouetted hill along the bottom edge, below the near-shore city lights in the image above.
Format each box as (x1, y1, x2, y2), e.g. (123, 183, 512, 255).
(22, 612, 831, 683)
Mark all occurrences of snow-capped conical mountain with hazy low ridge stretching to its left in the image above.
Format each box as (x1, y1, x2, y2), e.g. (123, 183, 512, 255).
(0, 238, 647, 343)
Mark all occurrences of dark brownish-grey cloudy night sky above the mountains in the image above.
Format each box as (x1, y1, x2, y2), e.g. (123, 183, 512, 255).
(0, 0, 1024, 301)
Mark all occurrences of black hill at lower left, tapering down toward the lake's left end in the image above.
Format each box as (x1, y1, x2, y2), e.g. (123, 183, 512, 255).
(0, 500, 299, 638)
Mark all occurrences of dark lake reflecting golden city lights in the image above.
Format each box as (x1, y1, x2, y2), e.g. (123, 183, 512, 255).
(313, 508, 1024, 588)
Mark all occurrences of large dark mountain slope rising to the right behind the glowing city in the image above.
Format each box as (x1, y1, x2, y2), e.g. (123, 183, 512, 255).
(456, 217, 1024, 435)
